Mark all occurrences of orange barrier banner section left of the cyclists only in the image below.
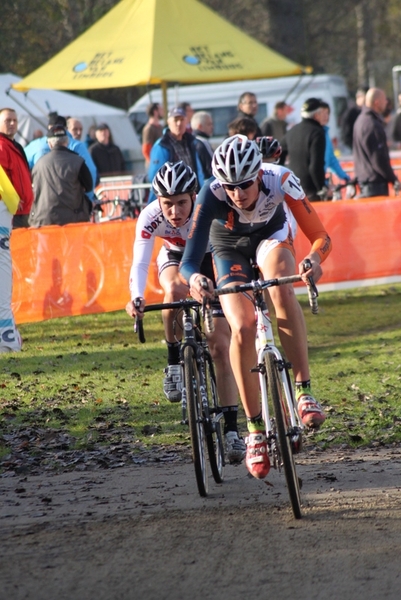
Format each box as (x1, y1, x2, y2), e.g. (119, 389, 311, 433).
(10, 220, 161, 323)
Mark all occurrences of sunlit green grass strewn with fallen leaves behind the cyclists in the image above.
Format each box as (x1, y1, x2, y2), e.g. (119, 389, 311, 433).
(0, 285, 401, 469)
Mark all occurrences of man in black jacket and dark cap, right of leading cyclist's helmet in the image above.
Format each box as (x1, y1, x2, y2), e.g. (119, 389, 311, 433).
(280, 98, 327, 202)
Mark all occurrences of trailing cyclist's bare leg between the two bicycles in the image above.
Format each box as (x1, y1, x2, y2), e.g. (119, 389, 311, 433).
(207, 317, 238, 406)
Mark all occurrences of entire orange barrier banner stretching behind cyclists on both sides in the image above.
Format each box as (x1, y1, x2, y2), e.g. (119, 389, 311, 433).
(11, 197, 401, 323)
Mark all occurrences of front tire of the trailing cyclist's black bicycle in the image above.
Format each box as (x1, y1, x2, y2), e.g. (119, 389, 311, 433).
(184, 346, 208, 497)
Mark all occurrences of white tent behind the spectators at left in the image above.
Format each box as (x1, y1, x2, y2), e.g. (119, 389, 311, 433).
(0, 73, 143, 161)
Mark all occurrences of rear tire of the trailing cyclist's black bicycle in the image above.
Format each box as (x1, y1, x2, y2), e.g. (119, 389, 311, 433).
(204, 354, 225, 483)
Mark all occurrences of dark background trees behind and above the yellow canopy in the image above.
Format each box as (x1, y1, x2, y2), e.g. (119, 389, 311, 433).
(0, 0, 401, 108)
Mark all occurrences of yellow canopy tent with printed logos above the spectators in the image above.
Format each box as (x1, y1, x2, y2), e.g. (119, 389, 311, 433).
(13, 0, 305, 109)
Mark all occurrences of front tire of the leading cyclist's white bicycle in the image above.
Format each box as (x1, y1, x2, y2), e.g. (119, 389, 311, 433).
(265, 353, 302, 519)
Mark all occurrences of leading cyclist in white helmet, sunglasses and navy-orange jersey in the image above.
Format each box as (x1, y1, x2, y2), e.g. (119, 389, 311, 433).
(180, 135, 331, 478)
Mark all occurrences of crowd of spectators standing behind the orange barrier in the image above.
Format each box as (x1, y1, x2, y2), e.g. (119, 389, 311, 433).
(0, 79, 401, 351)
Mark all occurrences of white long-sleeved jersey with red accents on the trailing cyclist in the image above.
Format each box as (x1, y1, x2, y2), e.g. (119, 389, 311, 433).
(129, 200, 211, 300)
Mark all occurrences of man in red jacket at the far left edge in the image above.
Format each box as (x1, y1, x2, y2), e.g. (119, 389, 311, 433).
(0, 108, 33, 229)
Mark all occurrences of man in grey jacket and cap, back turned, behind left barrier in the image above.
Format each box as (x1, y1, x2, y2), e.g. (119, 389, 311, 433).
(29, 125, 92, 227)
